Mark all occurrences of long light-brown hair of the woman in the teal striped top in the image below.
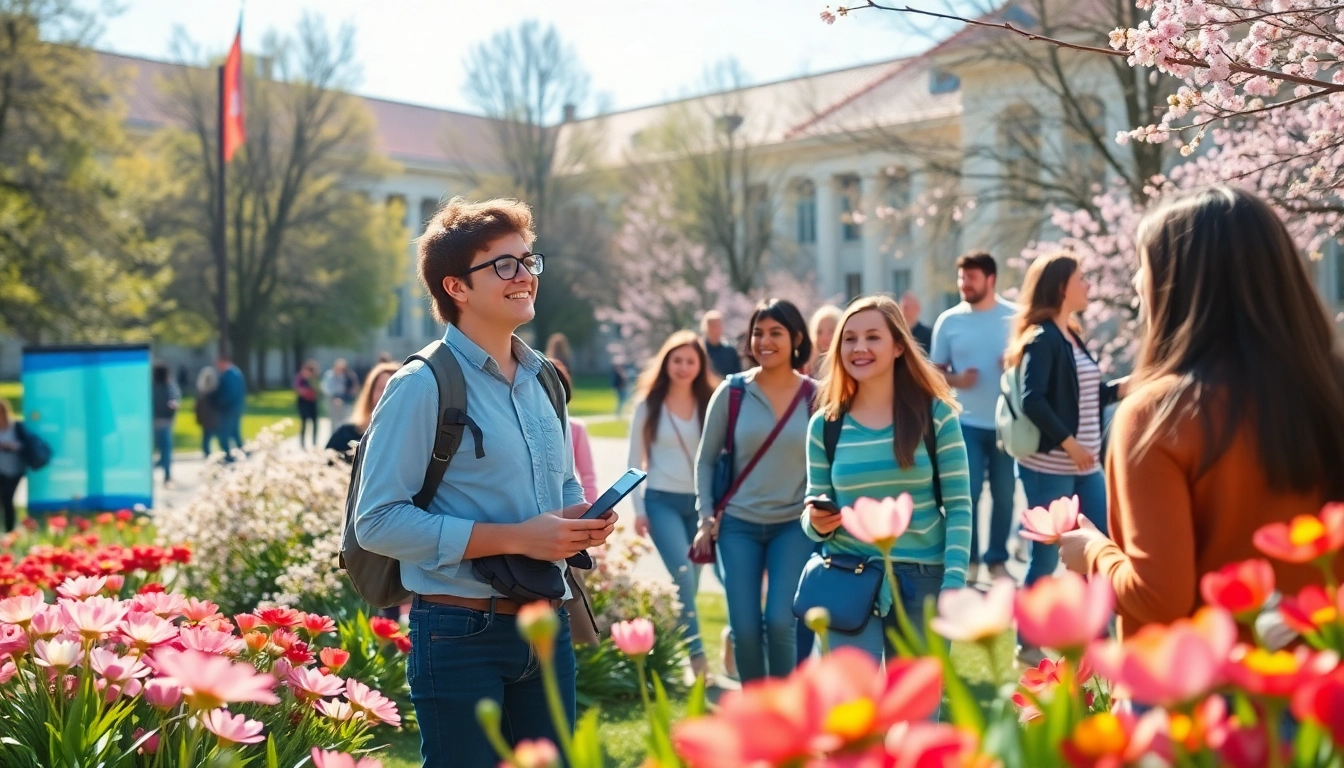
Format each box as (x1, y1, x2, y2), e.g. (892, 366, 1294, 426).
(817, 296, 961, 469)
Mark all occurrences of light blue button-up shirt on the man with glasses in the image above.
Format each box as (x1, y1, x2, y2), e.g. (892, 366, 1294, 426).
(355, 325, 583, 597)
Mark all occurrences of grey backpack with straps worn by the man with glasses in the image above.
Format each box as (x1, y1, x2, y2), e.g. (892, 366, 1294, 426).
(340, 340, 569, 608)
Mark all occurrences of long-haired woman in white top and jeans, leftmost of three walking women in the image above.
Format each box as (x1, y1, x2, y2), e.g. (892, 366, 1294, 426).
(626, 331, 718, 675)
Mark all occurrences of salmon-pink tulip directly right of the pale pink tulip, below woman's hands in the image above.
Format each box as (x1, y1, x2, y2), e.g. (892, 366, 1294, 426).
(1015, 572, 1116, 650)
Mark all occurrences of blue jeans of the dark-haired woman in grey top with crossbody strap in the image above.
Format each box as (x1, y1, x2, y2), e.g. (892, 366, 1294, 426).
(718, 515, 812, 683)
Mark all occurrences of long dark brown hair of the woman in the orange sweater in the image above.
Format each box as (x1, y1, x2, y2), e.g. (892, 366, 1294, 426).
(1134, 186, 1344, 499)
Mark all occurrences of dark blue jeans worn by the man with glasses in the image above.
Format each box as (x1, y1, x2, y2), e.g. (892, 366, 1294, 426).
(406, 594, 575, 768)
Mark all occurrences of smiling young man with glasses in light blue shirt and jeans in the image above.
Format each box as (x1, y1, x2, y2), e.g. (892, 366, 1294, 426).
(355, 198, 616, 767)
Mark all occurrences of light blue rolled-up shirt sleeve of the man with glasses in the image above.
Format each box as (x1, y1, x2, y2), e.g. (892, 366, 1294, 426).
(355, 363, 478, 570)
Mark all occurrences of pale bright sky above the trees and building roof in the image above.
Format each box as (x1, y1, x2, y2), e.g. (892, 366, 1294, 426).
(98, 0, 930, 112)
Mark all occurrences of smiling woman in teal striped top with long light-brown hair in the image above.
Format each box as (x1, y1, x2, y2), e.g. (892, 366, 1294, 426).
(802, 296, 972, 660)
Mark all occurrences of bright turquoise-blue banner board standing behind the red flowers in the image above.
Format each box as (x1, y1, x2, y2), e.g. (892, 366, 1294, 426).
(23, 344, 153, 514)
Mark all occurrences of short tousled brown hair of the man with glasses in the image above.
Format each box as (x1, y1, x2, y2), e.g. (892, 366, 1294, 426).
(418, 196, 536, 324)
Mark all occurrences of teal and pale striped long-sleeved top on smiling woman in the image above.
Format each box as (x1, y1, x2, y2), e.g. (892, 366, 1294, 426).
(802, 401, 970, 605)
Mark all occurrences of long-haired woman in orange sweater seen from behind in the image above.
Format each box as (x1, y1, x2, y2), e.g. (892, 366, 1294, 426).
(1060, 186, 1344, 638)
